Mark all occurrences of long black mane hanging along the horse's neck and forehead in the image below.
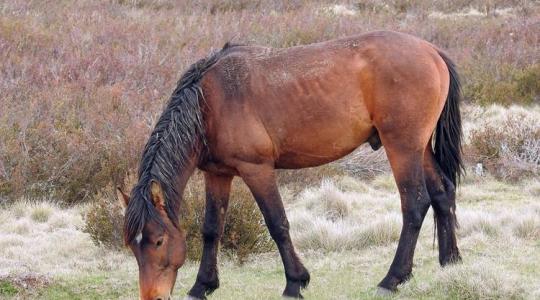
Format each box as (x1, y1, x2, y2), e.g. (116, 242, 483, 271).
(124, 43, 239, 244)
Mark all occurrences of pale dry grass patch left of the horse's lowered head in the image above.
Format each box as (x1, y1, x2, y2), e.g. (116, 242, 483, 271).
(0, 201, 133, 277)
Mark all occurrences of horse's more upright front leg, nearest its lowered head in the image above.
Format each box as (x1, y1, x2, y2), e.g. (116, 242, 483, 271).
(189, 172, 233, 299)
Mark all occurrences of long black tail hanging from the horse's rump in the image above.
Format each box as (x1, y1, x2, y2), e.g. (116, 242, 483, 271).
(434, 51, 464, 186)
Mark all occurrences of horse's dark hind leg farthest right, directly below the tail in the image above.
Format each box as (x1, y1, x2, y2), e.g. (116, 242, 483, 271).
(424, 149, 461, 266)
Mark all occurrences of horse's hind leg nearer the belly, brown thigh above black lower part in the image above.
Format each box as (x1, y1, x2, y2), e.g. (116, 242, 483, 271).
(379, 143, 430, 292)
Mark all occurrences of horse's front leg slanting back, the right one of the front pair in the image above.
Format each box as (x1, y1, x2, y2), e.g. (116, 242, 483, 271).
(238, 164, 309, 298)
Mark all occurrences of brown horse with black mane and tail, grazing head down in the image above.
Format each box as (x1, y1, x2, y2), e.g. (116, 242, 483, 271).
(118, 32, 462, 299)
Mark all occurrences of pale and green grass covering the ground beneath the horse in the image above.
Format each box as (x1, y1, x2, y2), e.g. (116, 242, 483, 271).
(0, 175, 540, 299)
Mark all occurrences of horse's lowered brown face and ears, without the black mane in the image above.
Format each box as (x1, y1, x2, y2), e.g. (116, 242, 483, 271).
(118, 181, 186, 300)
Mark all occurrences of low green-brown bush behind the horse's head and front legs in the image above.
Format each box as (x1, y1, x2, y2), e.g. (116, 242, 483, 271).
(83, 172, 274, 263)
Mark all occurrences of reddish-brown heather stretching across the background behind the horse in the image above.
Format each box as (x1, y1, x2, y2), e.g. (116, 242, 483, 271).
(0, 0, 540, 204)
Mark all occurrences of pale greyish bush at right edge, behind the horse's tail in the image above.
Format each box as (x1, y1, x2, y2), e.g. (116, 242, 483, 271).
(469, 107, 540, 179)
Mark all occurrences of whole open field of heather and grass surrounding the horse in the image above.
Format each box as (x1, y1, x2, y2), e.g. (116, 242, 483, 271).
(0, 0, 540, 299)
